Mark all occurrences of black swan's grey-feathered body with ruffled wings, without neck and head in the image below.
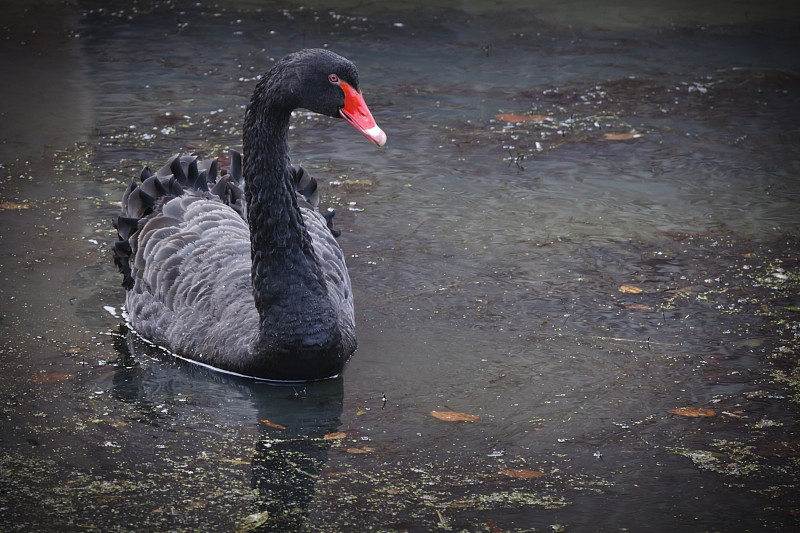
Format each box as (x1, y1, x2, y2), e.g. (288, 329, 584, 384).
(114, 152, 355, 379)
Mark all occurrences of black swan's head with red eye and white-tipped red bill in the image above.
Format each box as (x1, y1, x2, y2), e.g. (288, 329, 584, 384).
(273, 49, 386, 146)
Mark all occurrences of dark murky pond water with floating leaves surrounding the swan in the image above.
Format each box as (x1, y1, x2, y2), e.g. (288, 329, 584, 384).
(0, 0, 800, 532)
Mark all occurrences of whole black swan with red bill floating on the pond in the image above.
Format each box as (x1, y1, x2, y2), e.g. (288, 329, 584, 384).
(114, 49, 386, 381)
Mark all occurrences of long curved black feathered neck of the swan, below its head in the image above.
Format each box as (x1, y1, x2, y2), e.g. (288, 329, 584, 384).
(243, 80, 335, 345)
